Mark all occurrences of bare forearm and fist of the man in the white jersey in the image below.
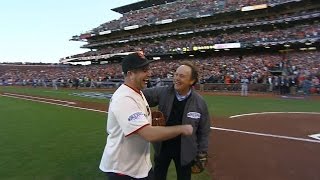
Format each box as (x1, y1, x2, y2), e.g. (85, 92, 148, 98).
(136, 125, 193, 142)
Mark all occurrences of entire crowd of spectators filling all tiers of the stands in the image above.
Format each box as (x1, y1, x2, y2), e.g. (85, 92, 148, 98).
(0, 0, 320, 93)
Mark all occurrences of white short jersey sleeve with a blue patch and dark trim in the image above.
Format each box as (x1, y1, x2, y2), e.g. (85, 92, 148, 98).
(112, 97, 150, 136)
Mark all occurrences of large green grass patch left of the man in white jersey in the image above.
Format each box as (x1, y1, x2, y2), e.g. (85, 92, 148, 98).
(0, 97, 106, 179)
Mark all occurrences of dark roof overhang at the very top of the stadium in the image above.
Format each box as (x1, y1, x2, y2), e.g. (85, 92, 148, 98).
(111, 0, 177, 14)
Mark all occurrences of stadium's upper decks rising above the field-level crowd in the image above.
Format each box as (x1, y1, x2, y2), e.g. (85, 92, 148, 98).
(60, 0, 320, 68)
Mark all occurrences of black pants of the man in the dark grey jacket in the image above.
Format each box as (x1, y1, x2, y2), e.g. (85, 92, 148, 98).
(154, 147, 191, 180)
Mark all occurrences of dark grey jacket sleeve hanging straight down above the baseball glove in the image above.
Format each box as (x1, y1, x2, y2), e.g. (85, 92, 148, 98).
(197, 99, 211, 152)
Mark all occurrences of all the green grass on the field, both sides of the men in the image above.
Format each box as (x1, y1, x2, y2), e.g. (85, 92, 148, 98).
(0, 87, 320, 180)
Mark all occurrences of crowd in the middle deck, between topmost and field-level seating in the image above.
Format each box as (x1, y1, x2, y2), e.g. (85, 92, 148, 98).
(66, 6, 320, 59)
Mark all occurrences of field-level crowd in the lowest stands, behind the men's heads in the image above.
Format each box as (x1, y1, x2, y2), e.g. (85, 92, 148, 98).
(0, 51, 320, 93)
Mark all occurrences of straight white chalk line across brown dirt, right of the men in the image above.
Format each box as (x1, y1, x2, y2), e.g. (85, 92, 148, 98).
(210, 127, 320, 143)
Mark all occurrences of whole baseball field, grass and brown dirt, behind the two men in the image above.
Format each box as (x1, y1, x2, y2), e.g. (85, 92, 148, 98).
(0, 87, 320, 180)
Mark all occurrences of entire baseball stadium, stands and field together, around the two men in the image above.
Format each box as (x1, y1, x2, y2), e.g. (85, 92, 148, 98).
(0, 0, 320, 180)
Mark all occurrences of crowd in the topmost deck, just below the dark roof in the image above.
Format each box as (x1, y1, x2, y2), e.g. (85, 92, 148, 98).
(92, 0, 293, 33)
